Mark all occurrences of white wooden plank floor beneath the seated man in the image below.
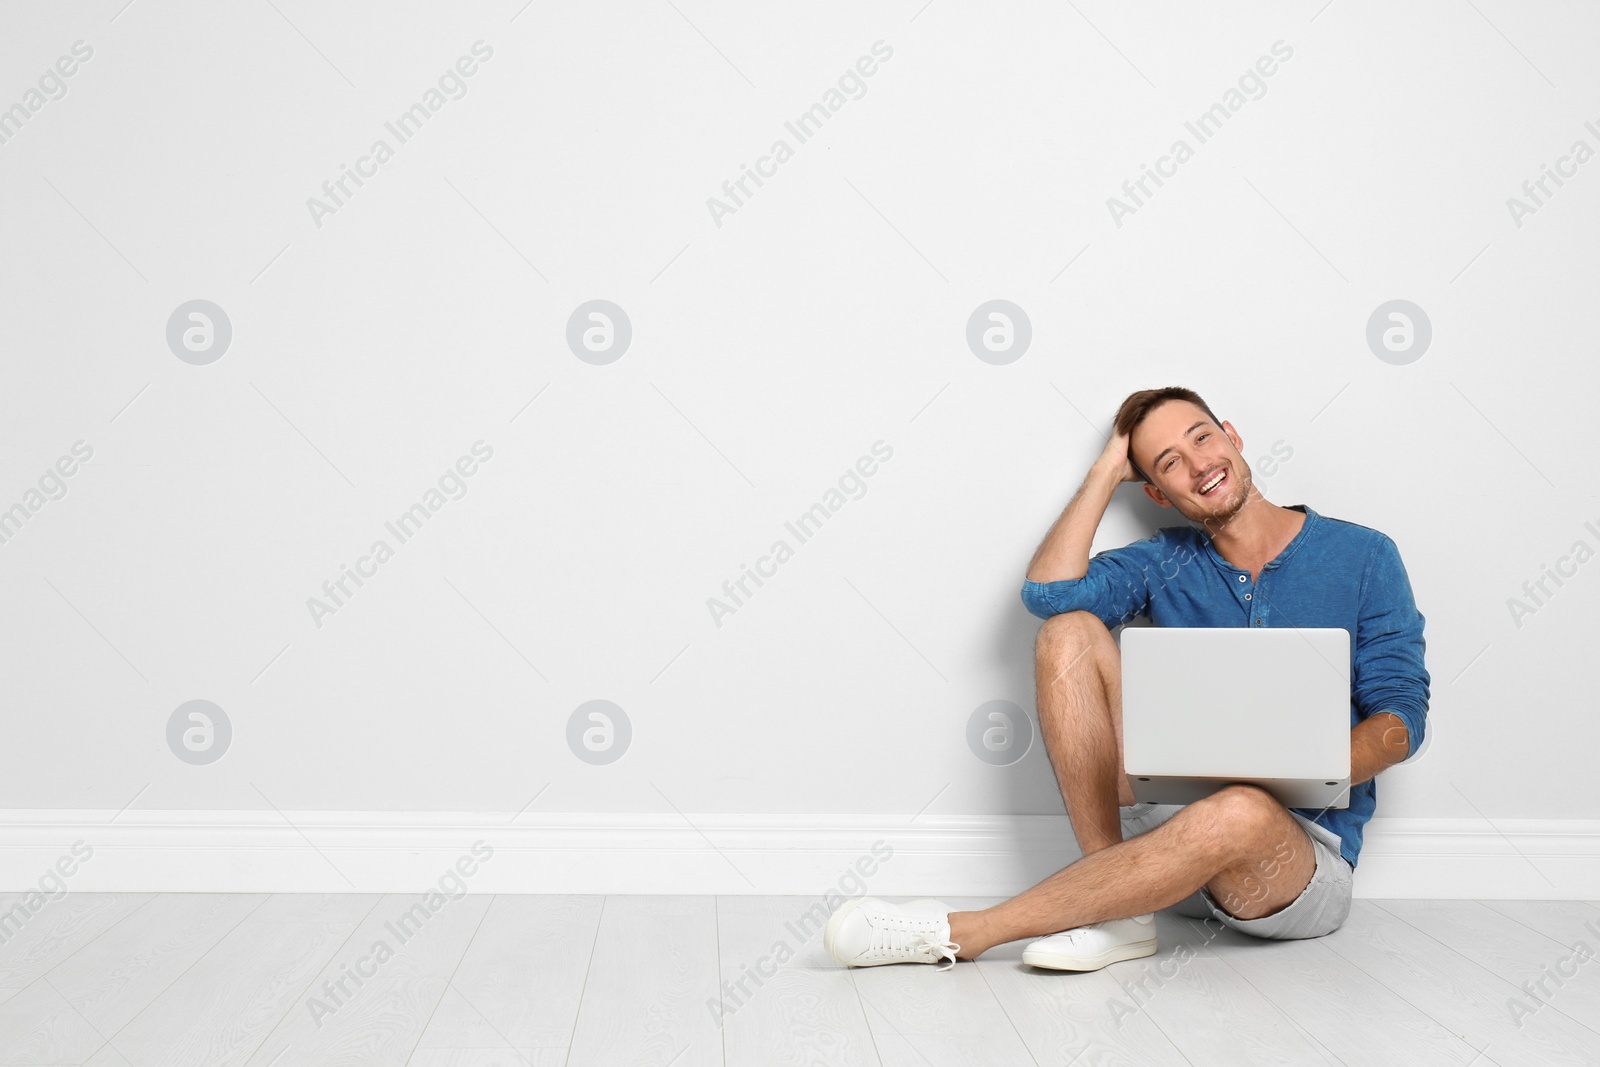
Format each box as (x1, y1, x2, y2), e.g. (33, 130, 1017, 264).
(0, 893, 1600, 1067)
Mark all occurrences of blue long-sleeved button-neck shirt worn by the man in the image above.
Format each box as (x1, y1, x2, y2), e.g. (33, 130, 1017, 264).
(1022, 504, 1429, 867)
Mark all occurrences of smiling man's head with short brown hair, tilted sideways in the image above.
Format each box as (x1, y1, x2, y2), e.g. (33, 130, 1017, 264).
(1114, 386, 1254, 528)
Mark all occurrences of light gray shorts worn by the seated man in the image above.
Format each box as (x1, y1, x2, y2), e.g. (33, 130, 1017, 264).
(1118, 803, 1355, 941)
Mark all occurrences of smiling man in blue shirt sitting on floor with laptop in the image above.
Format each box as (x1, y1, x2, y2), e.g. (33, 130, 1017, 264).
(824, 387, 1429, 971)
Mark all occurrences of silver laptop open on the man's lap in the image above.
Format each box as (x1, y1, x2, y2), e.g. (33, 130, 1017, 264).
(1120, 625, 1350, 808)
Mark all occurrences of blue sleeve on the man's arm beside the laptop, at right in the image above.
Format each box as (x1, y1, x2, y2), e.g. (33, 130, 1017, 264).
(1352, 536, 1430, 757)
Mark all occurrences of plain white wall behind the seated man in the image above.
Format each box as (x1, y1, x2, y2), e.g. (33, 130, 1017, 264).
(0, 0, 1600, 896)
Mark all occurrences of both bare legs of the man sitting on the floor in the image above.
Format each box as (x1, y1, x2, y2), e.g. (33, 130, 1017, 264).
(950, 611, 1317, 958)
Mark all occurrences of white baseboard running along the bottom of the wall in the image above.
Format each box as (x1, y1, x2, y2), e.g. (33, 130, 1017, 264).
(0, 808, 1600, 899)
